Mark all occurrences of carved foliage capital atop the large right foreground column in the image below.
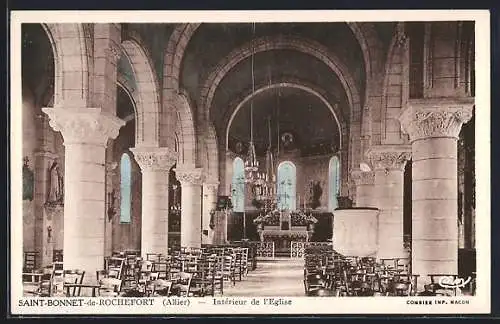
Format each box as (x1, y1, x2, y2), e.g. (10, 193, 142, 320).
(399, 99, 474, 142)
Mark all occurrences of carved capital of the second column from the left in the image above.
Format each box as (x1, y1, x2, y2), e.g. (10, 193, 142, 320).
(130, 147, 177, 171)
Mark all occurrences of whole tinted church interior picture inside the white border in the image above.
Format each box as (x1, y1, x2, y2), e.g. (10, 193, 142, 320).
(18, 21, 476, 297)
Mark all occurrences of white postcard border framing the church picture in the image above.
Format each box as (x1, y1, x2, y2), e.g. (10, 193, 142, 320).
(9, 10, 491, 315)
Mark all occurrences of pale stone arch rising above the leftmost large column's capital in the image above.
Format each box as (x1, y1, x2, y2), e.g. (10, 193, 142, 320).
(41, 23, 90, 108)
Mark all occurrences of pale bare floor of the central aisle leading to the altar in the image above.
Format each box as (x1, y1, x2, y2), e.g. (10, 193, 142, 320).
(224, 258, 305, 297)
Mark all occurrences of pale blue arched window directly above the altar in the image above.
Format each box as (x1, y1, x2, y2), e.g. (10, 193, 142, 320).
(277, 161, 297, 210)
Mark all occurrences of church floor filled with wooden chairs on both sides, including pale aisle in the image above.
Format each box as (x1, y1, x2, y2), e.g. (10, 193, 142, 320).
(23, 242, 476, 297)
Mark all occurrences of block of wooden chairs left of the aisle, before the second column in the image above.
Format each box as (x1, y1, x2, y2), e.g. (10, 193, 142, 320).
(97, 247, 254, 296)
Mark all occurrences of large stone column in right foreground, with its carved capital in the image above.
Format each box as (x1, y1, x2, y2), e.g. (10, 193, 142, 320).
(400, 98, 473, 284)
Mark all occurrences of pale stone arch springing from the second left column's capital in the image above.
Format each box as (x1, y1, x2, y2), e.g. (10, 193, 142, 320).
(121, 34, 160, 147)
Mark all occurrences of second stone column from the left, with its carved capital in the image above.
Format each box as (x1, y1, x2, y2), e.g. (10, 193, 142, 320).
(130, 147, 177, 258)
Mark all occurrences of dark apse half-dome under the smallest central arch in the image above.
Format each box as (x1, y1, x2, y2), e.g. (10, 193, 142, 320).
(228, 88, 339, 155)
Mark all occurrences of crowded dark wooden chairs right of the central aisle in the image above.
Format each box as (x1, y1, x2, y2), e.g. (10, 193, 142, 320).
(304, 250, 475, 296)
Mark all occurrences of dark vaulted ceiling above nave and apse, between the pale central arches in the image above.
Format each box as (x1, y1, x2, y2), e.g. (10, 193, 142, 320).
(181, 23, 368, 153)
